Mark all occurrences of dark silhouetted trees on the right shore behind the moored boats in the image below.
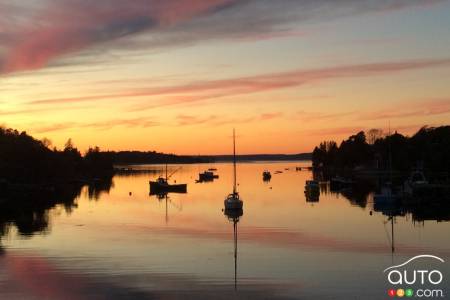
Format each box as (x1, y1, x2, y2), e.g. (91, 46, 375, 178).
(312, 126, 450, 173)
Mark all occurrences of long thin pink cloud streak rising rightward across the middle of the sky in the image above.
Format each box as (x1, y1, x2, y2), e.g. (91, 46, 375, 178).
(25, 58, 450, 110)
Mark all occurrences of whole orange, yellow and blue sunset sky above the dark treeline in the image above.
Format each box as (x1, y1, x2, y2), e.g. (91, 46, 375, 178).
(0, 0, 450, 154)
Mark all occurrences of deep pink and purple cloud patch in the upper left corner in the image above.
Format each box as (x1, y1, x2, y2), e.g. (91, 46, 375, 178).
(0, 0, 233, 73)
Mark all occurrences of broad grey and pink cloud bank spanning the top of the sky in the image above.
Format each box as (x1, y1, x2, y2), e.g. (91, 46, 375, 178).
(0, 0, 442, 73)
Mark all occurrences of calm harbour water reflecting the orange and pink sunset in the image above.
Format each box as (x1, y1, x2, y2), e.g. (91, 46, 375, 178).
(0, 162, 450, 299)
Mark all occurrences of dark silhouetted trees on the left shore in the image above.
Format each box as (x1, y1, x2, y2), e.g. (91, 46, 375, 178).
(0, 127, 113, 184)
